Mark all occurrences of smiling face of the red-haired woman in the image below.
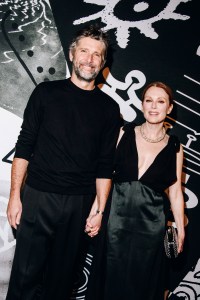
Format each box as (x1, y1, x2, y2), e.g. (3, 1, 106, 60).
(142, 86, 173, 124)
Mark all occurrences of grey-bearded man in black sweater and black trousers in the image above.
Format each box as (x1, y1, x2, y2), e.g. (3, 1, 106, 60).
(6, 25, 120, 300)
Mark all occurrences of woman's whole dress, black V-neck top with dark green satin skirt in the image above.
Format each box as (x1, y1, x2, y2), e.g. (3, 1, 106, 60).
(104, 123, 180, 300)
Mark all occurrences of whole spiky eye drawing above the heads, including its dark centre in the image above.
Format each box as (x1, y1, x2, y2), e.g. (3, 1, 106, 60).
(73, 0, 190, 48)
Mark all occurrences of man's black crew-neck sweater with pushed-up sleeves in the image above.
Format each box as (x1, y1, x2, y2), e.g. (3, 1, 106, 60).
(15, 79, 120, 194)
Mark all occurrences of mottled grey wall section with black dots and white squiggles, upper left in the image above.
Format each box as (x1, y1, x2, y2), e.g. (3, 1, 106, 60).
(0, 0, 67, 117)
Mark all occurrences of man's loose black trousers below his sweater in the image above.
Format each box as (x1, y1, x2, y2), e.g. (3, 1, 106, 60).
(6, 185, 95, 300)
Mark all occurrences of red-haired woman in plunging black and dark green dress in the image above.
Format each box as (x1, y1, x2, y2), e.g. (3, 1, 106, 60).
(105, 82, 184, 300)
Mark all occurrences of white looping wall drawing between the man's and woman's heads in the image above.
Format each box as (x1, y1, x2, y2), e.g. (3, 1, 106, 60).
(100, 68, 146, 122)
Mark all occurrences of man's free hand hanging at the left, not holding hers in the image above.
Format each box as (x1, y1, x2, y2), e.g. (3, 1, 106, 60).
(7, 198, 22, 229)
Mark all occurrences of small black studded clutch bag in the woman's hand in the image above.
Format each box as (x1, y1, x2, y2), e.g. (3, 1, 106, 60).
(164, 226, 178, 258)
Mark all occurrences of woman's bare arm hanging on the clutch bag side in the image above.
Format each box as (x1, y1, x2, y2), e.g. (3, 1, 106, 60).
(169, 145, 185, 253)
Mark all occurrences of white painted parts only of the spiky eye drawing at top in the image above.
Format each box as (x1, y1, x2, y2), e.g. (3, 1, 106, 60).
(73, 0, 191, 48)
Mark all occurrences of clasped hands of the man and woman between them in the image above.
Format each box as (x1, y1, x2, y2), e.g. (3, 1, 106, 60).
(85, 210, 103, 237)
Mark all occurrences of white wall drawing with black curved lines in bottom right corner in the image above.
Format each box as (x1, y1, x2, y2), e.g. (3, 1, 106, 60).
(170, 259, 200, 300)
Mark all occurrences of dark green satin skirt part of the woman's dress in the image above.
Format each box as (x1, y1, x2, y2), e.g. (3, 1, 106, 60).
(104, 181, 166, 300)
